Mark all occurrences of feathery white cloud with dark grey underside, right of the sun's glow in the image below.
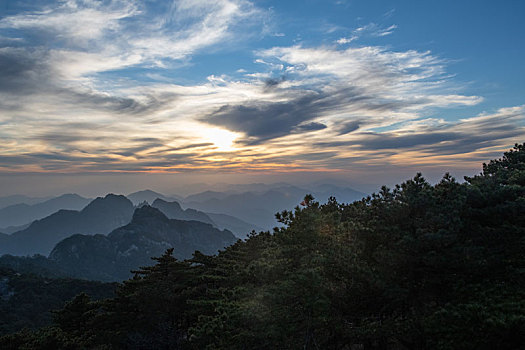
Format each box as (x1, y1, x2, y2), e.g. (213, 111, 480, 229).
(200, 46, 481, 145)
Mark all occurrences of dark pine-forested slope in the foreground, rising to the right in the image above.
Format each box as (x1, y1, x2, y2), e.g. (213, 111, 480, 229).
(0, 144, 525, 349)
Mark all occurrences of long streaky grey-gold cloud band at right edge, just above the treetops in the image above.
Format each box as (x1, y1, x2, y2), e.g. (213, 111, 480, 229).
(315, 106, 525, 161)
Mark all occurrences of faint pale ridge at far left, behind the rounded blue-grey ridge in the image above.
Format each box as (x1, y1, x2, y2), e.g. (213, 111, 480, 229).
(0, 194, 91, 227)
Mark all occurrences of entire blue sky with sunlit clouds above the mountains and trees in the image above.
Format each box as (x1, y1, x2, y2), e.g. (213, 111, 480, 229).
(0, 0, 525, 195)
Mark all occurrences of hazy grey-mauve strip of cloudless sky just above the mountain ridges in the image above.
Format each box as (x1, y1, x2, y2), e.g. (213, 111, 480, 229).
(0, 165, 489, 198)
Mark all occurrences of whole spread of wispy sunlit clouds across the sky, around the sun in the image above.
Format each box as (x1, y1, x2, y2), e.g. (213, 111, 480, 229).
(0, 0, 525, 173)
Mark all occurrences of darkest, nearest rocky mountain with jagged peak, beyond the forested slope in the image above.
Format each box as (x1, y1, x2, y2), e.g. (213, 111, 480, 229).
(49, 205, 237, 281)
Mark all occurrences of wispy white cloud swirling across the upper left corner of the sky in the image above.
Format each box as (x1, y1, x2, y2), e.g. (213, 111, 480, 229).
(0, 0, 262, 78)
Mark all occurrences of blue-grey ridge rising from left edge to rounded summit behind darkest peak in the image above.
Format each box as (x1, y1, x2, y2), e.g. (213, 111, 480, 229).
(0, 194, 134, 255)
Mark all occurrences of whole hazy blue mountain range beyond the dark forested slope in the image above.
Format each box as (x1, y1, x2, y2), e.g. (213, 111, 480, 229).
(0, 183, 364, 281)
